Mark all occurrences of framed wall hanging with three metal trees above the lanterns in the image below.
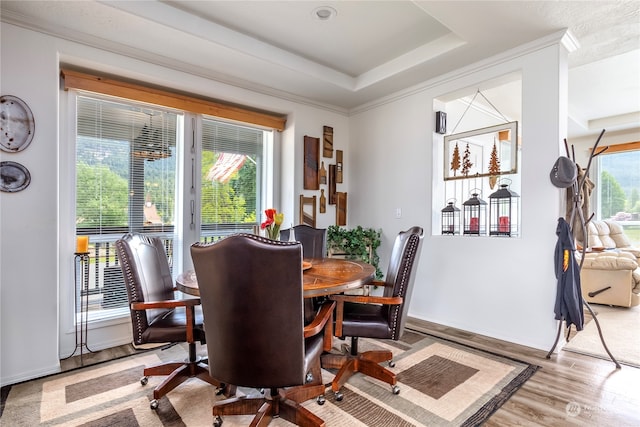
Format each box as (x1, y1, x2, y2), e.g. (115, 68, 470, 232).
(444, 122, 518, 181)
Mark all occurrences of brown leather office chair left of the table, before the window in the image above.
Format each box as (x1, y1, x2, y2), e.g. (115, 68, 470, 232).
(116, 233, 228, 409)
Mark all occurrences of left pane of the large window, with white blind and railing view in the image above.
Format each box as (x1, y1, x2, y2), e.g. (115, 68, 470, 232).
(76, 95, 179, 312)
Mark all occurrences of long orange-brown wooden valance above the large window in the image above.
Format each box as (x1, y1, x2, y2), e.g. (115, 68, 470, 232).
(60, 69, 287, 131)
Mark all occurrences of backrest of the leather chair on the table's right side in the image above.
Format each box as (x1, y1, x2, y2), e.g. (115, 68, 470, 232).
(384, 227, 424, 340)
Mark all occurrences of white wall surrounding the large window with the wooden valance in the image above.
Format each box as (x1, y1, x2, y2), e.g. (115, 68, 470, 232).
(0, 23, 349, 385)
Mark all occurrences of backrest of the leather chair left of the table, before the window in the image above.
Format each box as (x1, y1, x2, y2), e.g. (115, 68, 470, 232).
(116, 233, 174, 344)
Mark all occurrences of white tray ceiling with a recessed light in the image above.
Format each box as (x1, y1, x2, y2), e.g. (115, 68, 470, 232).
(0, 0, 640, 137)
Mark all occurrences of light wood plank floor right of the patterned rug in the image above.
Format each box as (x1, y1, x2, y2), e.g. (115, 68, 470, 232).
(407, 319, 640, 427)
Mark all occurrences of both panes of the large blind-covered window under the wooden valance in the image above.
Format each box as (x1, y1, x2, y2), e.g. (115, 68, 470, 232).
(75, 93, 273, 321)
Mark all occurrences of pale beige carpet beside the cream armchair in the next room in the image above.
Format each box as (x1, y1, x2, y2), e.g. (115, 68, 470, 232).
(563, 304, 640, 368)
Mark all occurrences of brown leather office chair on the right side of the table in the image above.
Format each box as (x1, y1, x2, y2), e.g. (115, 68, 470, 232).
(322, 227, 423, 400)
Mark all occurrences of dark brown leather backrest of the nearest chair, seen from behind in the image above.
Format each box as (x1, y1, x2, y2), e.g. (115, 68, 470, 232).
(191, 234, 305, 388)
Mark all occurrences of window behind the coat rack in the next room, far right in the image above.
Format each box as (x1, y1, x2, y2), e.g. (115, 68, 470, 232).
(596, 143, 640, 246)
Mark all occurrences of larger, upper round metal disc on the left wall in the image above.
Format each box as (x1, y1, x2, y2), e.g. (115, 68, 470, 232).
(0, 95, 35, 153)
